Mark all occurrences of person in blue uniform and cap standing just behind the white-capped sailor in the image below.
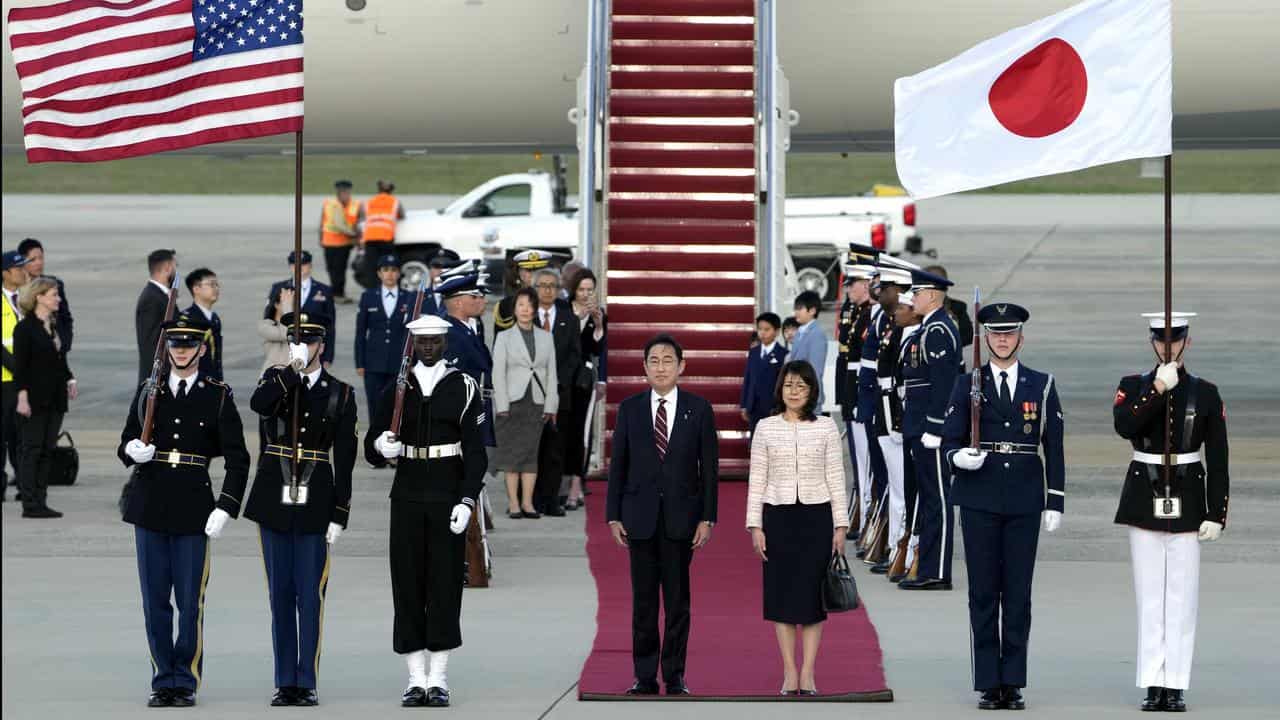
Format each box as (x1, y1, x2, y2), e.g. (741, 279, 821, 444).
(356, 255, 417, 418)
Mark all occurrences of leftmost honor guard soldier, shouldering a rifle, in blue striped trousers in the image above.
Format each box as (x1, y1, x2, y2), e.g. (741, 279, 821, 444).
(118, 315, 250, 707)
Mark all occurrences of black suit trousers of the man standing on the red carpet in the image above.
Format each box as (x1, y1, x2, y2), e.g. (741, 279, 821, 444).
(628, 506, 694, 684)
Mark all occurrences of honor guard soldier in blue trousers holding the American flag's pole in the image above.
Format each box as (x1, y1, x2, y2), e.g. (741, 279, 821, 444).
(244, 313, 357, 707)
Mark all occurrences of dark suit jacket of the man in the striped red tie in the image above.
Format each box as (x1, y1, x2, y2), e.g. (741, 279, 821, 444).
(605, 389, 719, 541)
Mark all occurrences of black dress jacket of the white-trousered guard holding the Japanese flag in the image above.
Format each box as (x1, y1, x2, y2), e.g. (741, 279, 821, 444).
(1112, 368, 1229, 533)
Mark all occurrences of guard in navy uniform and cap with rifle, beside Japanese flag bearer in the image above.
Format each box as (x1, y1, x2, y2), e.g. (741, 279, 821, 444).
(942, 302, 1066, 710)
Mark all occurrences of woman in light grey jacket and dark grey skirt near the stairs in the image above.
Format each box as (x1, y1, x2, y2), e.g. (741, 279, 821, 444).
(493, 287, 559, 519)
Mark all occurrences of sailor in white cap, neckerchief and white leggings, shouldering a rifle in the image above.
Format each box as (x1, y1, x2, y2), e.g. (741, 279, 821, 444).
(365, 315, 489, 707)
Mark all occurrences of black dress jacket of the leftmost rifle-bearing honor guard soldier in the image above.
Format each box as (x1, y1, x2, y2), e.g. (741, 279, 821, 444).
(116, 374, 250, 536)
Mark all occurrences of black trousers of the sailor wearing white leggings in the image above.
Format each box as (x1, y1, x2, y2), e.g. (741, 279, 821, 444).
(390, 501, 467, 655)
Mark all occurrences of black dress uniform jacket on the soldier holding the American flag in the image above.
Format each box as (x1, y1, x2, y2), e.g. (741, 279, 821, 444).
(244, 366, 357, 533)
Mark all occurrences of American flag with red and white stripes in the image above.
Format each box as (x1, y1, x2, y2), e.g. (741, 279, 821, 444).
(9, 0, 302, 163)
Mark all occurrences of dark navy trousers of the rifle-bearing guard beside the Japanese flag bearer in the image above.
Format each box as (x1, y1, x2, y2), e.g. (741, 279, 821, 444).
(960, 507, 1041, 691)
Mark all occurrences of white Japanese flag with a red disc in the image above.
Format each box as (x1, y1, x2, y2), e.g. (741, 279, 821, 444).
(893, 0, 1174, 199)
